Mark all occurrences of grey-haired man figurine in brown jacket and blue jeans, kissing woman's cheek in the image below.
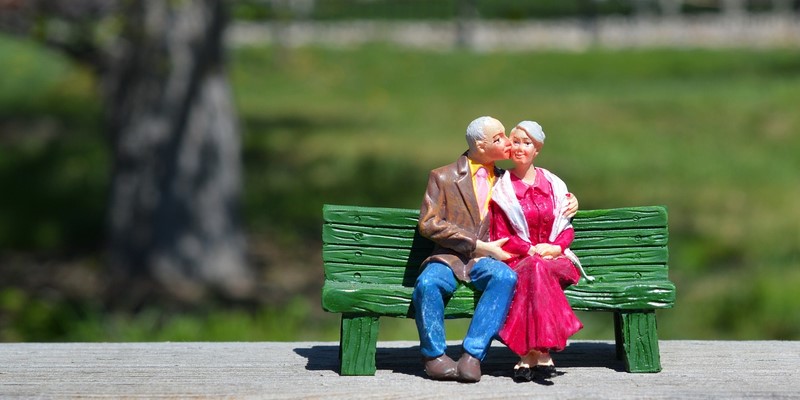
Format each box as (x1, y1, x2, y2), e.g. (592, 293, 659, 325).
(413, 117, 516, 382)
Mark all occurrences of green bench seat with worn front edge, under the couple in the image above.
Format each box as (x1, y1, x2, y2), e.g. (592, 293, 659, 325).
(322, 281, 675, 317)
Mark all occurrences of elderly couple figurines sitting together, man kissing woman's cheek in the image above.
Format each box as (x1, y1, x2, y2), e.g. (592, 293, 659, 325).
(413, 116, 585, 382)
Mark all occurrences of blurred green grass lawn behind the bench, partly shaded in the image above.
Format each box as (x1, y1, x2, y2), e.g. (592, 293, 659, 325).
(0, 32, 800, 340)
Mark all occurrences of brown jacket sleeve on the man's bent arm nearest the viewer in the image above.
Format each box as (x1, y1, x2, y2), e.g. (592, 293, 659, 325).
(419, 171, 478, 255)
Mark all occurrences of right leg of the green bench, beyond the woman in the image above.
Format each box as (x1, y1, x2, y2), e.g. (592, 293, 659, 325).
(614, 310, 661, 372)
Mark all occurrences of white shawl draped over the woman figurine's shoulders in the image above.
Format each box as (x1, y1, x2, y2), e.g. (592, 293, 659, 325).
(492, 168, 594, 282)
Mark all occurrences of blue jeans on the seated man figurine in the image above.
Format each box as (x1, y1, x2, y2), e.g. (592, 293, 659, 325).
(412, 257, 517, 361)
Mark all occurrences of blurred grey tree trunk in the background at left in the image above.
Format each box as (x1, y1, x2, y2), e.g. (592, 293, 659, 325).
(103, 0, 253, 300)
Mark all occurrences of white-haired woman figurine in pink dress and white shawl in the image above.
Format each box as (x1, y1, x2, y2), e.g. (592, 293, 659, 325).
(491, 121, 591, 381)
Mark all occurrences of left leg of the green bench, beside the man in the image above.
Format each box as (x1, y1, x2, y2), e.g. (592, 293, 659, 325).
(339, 314, 380, 375)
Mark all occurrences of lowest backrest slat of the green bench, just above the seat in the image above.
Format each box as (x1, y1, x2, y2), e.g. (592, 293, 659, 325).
(325, 262, 668, 287)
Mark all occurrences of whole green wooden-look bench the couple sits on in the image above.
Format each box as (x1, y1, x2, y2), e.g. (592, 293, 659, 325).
(322, 205, 675, 375)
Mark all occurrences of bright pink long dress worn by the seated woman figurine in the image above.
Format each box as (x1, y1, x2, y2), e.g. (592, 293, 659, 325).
(491, 170, 583, 355)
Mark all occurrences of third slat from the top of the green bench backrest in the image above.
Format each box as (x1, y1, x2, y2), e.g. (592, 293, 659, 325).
(322, 244, 668, 267)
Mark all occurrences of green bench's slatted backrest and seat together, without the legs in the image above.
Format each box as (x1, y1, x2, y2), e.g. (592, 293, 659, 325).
(322, 205, 674, 316)
